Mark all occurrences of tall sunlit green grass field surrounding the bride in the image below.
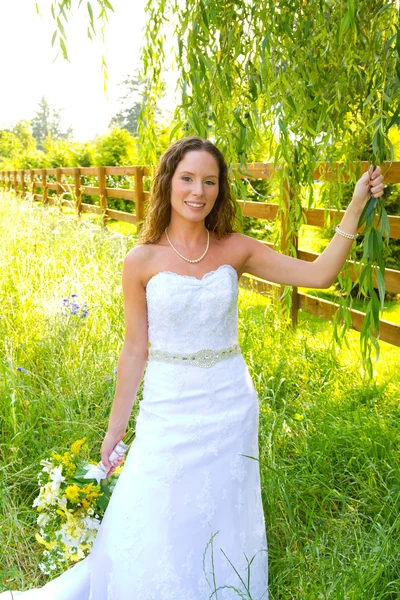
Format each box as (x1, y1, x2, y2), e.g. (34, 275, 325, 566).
(0, 195, 400, 600)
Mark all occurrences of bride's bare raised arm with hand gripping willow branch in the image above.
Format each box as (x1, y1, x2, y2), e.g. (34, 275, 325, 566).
(243, 167, 384, 288)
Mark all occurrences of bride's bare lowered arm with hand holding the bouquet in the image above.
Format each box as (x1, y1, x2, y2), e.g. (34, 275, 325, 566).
(101, 246, 148, 466)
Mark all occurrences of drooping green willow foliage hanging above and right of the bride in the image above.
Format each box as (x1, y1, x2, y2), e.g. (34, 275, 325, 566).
(139, 0, 400, 366)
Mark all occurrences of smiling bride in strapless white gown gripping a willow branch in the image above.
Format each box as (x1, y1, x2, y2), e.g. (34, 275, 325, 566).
(0, 137, 384, 600)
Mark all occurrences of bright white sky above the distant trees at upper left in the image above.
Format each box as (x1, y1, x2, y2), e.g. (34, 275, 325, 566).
(0, 0, 175, 141)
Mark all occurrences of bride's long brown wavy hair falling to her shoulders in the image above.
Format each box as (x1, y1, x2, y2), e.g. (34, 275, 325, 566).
(139, 136, 237, 244)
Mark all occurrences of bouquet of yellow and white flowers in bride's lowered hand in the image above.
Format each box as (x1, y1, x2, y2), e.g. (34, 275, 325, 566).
(33, 430, 135, 575)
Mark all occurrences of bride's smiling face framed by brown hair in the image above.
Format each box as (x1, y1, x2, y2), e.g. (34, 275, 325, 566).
(171, 150, 219, 221)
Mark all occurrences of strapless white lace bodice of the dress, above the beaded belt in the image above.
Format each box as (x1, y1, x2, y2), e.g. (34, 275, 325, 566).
(146, 264, 238, 352)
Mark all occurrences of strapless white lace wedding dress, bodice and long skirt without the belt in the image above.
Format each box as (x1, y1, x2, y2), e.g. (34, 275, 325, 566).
(0, 264, 268, 600)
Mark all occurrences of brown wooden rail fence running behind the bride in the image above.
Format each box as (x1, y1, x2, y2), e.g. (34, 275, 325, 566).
(0, 162, 400, 346)
